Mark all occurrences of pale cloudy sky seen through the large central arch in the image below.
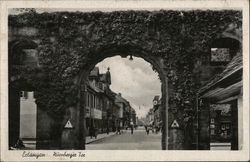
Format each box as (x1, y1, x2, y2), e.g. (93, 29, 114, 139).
(96, 56, 161, 118)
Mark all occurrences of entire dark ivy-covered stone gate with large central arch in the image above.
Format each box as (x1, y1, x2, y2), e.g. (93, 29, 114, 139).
(9, 10, 242, 150)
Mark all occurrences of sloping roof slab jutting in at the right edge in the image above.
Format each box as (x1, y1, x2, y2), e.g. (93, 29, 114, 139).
(199, 53, 243, 93)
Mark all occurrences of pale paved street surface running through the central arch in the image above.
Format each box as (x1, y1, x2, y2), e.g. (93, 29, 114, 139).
(86, 129, 161, 150)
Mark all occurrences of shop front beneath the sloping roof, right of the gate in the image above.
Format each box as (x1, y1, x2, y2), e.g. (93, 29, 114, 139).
(210, 102, 238, 150)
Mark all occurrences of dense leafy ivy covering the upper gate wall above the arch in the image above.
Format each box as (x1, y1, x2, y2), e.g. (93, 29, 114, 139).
(9, 10, 242, 120)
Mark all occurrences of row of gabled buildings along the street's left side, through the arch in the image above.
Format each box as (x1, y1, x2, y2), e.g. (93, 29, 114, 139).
(82, 67, 136, 134)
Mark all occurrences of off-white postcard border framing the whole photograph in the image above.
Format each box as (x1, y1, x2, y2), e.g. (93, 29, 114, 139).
(0, 0, 249, 161)
